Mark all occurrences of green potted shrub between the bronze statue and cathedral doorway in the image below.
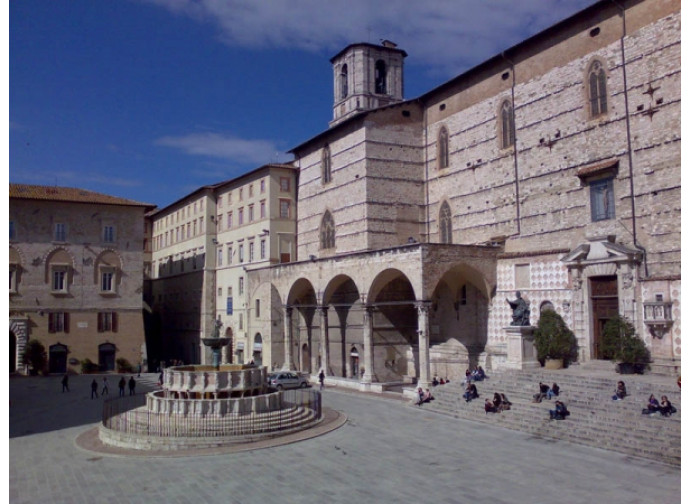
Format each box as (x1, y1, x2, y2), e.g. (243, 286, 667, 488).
(534, 310, 577, 369)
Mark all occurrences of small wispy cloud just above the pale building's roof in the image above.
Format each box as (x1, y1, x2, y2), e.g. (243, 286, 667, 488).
(155, 132, 291, 165)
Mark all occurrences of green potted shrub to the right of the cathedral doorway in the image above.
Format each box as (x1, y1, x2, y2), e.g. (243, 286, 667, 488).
(602, 315, 651, 374)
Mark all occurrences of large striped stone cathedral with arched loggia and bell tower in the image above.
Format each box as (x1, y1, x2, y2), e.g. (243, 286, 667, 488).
(248, 0, 681, 389)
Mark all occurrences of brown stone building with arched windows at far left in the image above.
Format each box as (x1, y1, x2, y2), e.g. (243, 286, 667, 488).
(9, 184, 153, 373)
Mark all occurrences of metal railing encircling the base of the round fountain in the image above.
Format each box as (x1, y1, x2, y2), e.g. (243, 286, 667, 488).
(102, 389, 321, 438)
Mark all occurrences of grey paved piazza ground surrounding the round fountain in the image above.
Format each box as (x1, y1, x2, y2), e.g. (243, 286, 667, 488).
(9, 374, 681, 504)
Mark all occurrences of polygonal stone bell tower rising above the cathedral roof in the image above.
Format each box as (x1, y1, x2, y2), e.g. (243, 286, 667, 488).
(329, 40, 407, 127)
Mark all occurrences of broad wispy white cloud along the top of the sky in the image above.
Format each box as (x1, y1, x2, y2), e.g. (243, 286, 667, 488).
(146, 0, 594, 75)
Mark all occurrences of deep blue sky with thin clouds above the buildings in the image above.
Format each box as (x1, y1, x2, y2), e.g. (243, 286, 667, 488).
(8, 0, 594, 207)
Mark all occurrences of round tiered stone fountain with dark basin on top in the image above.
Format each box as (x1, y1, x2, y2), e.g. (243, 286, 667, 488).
(98, 320, 323, 451)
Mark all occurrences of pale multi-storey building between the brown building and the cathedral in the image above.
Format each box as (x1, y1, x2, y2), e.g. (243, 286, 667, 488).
(148, 164, 296, 363)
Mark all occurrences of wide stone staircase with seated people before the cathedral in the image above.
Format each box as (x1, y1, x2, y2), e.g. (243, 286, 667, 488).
(416, 368, 681, 466)
